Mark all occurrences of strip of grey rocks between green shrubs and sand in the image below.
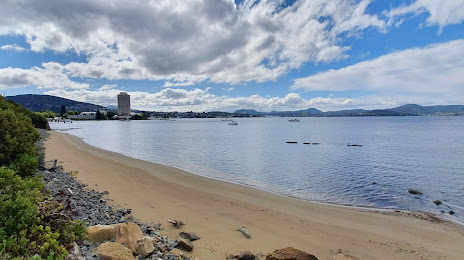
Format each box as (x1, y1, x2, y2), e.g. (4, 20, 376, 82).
(38, 159, 189, 259)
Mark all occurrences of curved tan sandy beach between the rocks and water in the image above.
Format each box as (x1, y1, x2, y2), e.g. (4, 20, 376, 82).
(45, 132, 464, 260)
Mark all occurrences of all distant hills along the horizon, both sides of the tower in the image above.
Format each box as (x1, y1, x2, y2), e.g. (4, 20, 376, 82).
(6, 94, 464, 117)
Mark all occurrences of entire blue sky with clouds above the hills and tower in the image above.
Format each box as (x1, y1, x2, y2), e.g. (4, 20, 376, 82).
(0, 0, 464, 112)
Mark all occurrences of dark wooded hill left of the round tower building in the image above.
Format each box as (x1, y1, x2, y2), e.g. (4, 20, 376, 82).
(6, 94, 107, 113)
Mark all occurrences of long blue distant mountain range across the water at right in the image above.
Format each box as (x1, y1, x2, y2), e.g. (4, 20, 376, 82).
(234, 104, 464, 117)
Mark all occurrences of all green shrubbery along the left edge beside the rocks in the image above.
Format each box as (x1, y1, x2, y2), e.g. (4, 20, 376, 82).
(0, 96, 87, 259)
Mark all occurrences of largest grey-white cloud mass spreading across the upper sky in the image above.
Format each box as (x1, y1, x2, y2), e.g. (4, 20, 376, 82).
(0, 0, 385, 83)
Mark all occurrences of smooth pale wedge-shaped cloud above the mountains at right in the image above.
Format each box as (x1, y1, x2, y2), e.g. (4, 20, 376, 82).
(291, 40, 464, 94)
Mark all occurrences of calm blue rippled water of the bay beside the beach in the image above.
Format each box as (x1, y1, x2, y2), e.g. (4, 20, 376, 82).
(51, 117, 464, 221)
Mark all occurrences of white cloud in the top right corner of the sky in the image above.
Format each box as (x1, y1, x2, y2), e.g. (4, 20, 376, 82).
(385, 0, 464, 31)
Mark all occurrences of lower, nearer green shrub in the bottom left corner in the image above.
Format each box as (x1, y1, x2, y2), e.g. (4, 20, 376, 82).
(0, 167, 87, 259)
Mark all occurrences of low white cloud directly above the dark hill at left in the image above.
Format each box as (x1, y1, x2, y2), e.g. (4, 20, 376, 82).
(0, 63, 89, 89)
